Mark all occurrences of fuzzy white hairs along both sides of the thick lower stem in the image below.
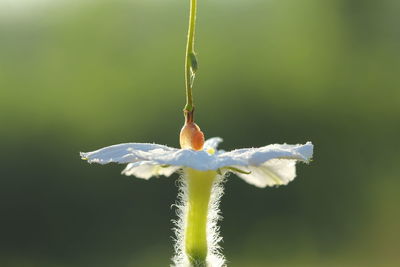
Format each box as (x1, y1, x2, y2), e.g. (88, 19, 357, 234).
(171, 172, 226, 267)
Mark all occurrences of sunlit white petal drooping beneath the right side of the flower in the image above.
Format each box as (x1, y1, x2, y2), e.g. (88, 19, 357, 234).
(236, 159, 296, 187)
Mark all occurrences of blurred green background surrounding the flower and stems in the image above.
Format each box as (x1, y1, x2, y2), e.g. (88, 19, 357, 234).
(0, 0, 400, 267)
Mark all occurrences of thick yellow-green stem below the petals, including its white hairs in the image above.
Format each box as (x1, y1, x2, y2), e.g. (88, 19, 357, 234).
(172, 168, 226, 267)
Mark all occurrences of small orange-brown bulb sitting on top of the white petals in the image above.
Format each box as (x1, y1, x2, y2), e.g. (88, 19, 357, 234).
(179, 122, 204, 150)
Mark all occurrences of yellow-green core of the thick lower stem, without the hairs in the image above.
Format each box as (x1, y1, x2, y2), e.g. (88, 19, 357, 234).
(185, 169, 217, 266)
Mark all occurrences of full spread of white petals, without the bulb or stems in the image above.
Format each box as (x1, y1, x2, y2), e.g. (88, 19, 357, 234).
(81, 137, 313, 187)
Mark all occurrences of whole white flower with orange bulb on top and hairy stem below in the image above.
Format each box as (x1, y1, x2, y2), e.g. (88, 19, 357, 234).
(81, 137, 313, 267)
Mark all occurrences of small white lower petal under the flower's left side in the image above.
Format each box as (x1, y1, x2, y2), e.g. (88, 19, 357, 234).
(122, 162, 179, 179)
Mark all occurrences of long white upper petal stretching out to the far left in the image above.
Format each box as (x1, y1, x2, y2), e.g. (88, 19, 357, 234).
(80, 143, 177, 164)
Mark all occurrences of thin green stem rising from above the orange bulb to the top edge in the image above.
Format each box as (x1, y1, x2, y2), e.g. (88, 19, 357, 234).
(184, 0, 197, 111)
